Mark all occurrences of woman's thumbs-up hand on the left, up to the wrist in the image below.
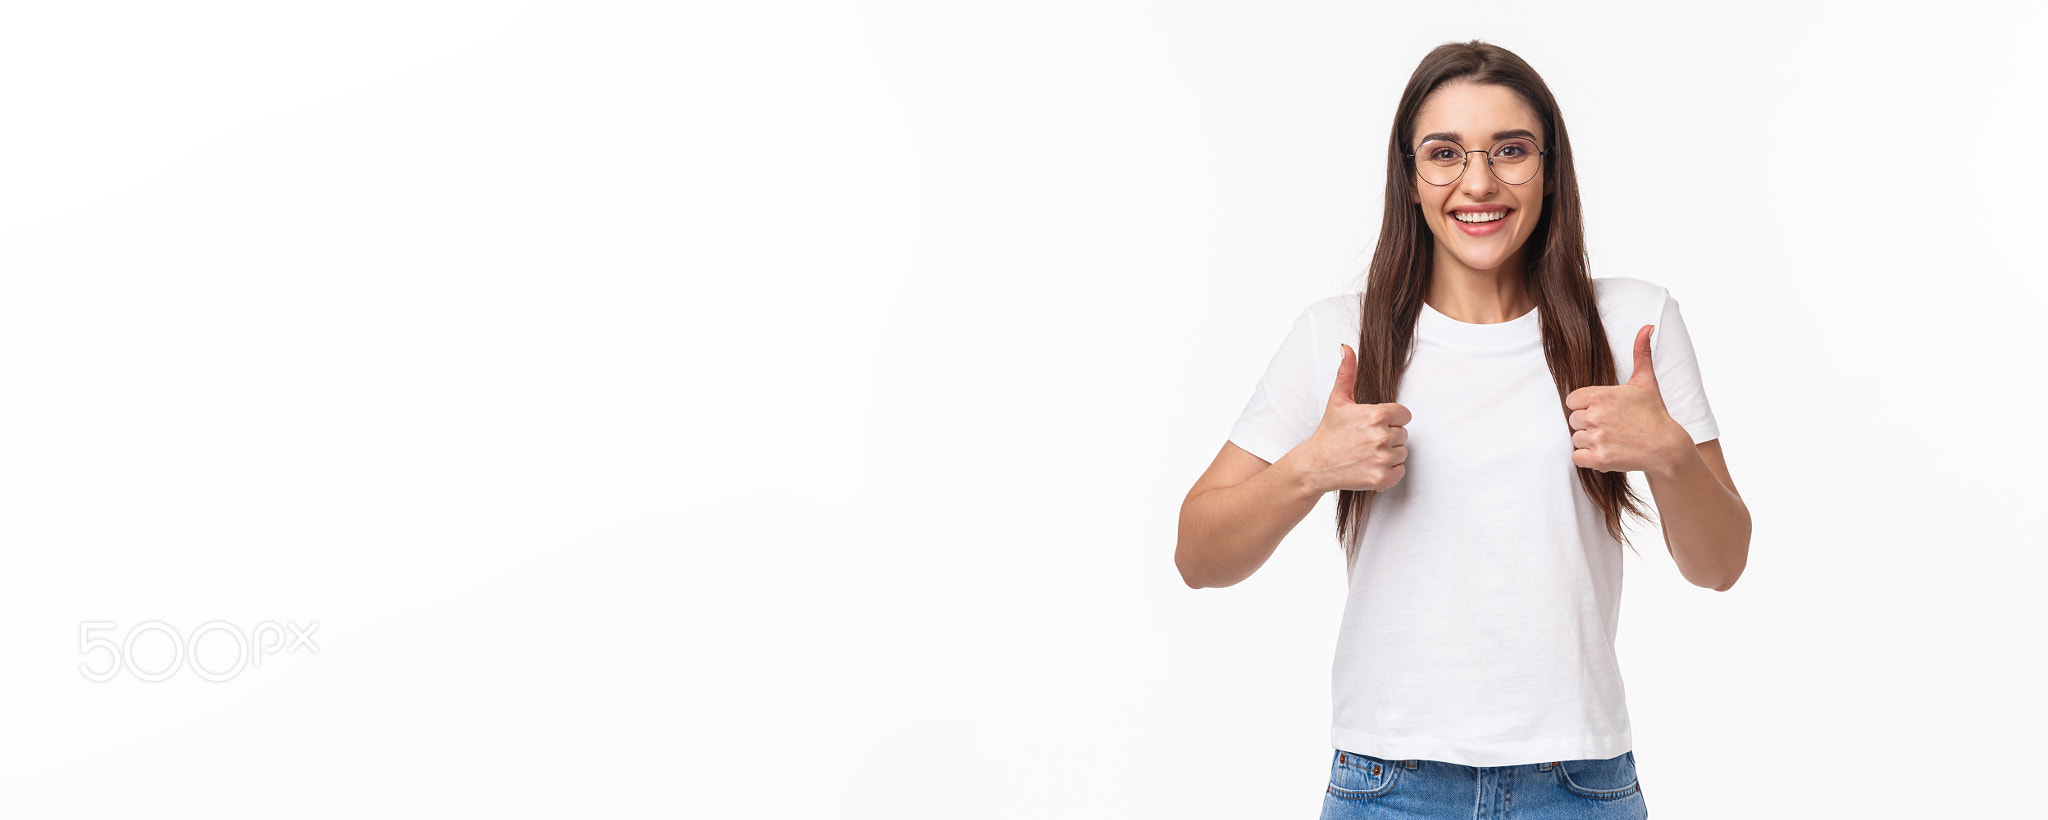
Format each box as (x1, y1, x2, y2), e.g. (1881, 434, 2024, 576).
(1288, 344, 1413, 494)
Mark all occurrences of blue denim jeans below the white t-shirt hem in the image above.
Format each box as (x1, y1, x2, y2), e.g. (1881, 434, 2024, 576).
(1323, 748, 1651, 820)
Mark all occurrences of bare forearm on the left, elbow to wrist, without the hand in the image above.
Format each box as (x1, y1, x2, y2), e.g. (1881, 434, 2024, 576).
(1174, 455, 1323, 588)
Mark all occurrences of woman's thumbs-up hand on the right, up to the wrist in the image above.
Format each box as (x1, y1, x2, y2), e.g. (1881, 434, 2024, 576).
(1565, 324, 1692, 472)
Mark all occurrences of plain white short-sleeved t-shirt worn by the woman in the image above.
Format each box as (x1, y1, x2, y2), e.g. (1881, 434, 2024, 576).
(1231, 277, 1720, 767)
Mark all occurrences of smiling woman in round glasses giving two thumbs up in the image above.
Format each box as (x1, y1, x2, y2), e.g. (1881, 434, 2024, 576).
(1174, 41, 1749, 818)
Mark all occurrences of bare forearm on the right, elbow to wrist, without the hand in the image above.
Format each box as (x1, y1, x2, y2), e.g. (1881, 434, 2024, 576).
(1645, 437, 1749, 590)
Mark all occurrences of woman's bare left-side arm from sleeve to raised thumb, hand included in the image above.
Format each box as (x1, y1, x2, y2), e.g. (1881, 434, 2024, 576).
(1174, 344, 1413, 588)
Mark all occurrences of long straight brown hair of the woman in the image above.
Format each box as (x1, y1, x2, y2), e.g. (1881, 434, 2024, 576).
(1337, 39, 1649, 564)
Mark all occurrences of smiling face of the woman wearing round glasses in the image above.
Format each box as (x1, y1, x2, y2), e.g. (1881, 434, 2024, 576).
(1407, 82, 1550, 271)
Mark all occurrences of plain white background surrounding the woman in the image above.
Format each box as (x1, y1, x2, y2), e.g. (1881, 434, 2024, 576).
(0, 2, 2048, 818)
